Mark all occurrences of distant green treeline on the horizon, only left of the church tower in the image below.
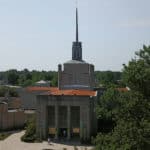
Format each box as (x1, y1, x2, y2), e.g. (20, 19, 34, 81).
(0, 69, 57, 87)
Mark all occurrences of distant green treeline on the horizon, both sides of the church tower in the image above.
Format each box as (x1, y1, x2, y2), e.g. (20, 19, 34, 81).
(0, 69, 122, 87)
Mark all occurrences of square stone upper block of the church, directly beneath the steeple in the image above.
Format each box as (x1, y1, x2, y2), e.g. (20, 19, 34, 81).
(58, 61, 95, 90)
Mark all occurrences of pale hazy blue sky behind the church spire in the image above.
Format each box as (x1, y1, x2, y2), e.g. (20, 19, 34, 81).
(0, 0, 150, 71)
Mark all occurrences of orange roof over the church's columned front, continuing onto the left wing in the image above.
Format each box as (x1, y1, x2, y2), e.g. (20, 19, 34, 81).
(27, 87, 97, 96)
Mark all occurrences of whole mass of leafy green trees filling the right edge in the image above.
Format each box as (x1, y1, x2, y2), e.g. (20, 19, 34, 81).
(95, 46, 150, 150)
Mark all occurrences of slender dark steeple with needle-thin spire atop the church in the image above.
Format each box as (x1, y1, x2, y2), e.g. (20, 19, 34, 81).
(72, 7, 82, 61)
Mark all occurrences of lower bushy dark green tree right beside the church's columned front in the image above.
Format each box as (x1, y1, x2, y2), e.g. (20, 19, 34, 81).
(95, 89, 150, 150)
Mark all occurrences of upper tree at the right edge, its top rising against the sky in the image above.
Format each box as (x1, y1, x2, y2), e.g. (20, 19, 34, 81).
(123, 45, 150, 98)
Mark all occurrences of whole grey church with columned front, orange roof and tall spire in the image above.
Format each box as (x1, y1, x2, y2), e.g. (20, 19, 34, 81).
(36, 9, 97, 140)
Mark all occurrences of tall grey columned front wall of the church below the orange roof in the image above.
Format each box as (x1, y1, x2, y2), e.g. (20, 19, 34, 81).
(36, 95, 97, 140)
